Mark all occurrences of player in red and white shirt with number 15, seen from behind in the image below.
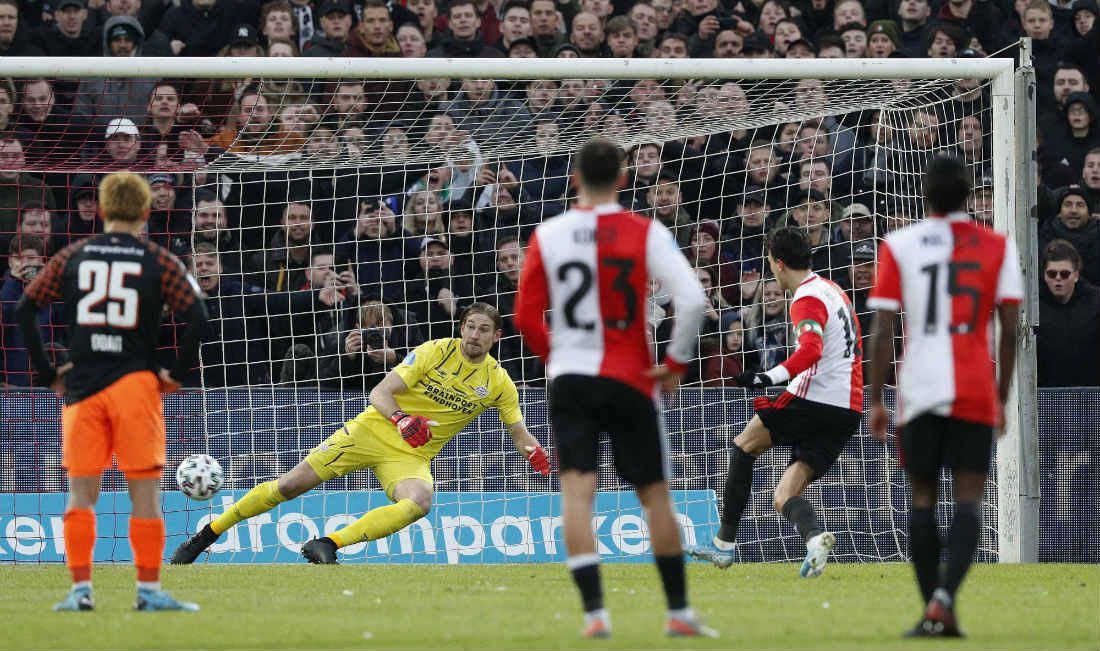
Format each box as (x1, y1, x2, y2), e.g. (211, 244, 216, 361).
(867, 156, 1023, 637)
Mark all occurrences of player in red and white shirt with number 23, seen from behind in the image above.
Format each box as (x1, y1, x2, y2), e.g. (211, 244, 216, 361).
(516, 134, 717, 637)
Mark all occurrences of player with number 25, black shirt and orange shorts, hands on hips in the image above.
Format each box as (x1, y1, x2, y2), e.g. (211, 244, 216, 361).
(15, 172, 207, 611)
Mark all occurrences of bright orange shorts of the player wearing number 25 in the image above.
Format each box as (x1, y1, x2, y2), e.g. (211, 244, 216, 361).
(62, 371, 165, 479)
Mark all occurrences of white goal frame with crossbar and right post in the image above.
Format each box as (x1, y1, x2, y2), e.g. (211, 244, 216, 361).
(0, 53, 1040, 562)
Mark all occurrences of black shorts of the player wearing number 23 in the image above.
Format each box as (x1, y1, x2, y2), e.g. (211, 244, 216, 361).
(550, 375, 668, 486)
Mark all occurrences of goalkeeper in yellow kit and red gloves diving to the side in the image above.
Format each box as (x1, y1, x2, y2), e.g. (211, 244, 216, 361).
(172, 302, 550, 564)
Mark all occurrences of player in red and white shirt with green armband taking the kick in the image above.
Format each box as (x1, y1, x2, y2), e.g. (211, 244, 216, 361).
(688, 228, 864, 578)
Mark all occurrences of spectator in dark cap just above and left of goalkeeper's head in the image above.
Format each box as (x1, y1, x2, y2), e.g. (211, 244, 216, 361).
(405, 235, 474, 340)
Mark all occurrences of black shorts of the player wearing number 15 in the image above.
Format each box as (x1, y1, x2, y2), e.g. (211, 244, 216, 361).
(898, 413, 993, 477)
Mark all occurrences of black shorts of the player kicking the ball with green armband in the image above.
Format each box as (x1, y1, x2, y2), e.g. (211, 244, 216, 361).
(752, 391, 859, 479)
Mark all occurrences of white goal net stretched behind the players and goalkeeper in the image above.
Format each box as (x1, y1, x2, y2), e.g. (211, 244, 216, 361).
(0, 59, 1019, 563)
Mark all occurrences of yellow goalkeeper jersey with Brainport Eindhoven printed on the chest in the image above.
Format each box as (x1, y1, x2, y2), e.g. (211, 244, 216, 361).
(355, 339, 524, 459)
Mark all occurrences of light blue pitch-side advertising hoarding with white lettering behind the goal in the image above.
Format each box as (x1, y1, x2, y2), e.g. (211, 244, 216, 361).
(0, 490, 718, 564)
